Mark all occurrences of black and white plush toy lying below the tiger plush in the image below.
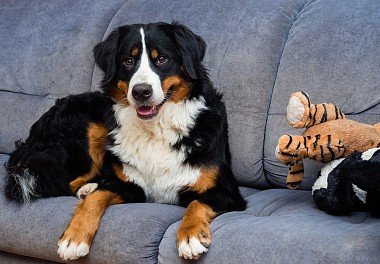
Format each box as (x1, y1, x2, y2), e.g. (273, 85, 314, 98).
(312, 148, 380, 217)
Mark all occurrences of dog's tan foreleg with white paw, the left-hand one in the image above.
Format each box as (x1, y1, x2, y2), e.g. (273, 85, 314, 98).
(57, 190, 123, 260)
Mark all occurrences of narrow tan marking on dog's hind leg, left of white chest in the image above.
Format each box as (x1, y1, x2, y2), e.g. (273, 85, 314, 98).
(70, 123, 108, 194)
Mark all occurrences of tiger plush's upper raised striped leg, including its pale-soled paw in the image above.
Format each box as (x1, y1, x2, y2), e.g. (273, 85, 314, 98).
(286, 92, 346, 128)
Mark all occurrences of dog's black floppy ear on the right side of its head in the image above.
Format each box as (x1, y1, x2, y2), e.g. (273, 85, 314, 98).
(172, 23, 206, 79)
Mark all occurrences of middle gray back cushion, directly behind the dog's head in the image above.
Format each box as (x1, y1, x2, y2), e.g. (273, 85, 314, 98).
(92, 0, 314, 187)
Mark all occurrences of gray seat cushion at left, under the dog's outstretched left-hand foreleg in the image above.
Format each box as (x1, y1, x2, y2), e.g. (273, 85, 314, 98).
(0, 154, 259, 264)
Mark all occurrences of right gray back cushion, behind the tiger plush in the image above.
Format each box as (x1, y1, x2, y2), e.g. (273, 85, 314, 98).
(264, 0, 380, 189)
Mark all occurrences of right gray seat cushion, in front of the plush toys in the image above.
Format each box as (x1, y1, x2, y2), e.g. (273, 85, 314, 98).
(158, 190, 380, 264)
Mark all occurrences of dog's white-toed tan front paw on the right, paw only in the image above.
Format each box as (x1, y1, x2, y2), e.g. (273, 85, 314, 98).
(177, 224, 211, 259)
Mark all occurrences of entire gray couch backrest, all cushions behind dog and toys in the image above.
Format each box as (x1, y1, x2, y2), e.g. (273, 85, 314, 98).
(0, 0, 380, 189)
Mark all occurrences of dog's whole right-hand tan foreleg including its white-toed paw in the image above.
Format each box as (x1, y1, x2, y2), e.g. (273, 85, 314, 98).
(177, 201, 216, 259)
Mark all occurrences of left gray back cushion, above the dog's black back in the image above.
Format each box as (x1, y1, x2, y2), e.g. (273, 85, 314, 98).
(0, 0, 124, 153)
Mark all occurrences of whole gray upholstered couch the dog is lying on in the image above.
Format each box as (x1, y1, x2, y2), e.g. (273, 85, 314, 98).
(0, 0, 380, 264)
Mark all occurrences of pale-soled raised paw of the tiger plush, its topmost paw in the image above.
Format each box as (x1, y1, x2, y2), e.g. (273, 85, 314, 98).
(286, 92, 310, 128)
